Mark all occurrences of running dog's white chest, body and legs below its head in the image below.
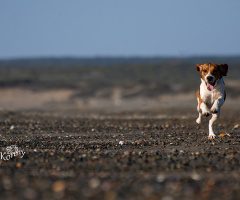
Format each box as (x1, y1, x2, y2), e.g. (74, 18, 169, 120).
(196, 78, 225, 139)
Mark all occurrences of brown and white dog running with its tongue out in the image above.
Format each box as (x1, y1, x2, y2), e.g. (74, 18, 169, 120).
(196, 63, 228, 139)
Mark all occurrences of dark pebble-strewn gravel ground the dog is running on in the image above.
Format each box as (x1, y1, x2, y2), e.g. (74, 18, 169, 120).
(0, 109, 240, 200)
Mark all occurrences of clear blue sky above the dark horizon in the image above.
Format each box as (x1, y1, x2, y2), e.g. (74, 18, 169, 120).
(0, 0, 240, 59)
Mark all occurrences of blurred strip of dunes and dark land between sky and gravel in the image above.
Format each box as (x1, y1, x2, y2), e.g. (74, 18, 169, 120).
(0, 57, 240, 110)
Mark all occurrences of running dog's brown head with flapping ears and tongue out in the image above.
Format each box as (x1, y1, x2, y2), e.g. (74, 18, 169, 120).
(196, 63, 228, 91)
